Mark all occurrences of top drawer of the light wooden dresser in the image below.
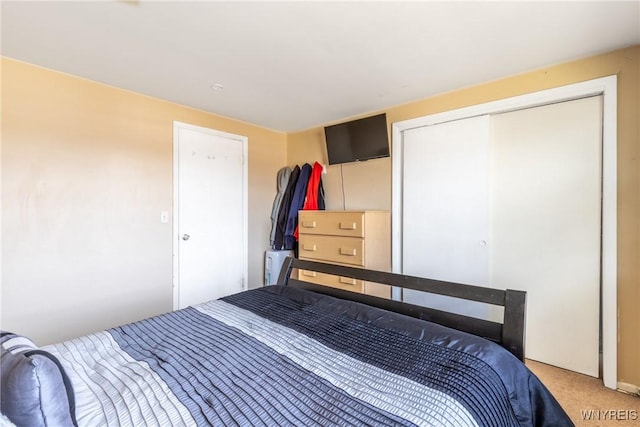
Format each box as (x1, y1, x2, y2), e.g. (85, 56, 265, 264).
(298, 211, 364, 237)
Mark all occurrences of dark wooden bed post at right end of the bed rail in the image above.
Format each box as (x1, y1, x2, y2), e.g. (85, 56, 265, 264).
(502, 289, 527, 362)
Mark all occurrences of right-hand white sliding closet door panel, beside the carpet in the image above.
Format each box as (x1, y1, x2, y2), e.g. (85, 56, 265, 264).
(490, 97, 602, 376)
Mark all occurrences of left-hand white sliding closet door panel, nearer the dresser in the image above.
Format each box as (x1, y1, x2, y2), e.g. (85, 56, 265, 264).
(402, 116, 496, 317)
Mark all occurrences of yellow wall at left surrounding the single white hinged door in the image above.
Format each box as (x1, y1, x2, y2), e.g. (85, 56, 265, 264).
(0, 58, 286, 344)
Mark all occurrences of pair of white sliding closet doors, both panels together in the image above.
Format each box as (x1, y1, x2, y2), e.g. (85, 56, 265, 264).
(402, 96, 602, 376)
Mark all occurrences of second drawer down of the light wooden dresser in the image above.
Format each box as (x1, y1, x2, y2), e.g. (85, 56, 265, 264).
(298, 234, 364, 266)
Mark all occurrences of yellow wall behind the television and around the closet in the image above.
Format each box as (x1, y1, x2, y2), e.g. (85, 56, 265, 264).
(287, 46, 640, 385)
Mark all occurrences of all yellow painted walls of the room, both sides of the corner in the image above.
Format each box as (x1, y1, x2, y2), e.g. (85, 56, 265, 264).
(0, 46, 640, 385)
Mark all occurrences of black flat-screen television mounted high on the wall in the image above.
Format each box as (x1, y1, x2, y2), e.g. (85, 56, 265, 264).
(324, 114, 389, 165)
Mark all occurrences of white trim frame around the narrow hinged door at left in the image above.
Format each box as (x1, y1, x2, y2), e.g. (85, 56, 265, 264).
(172, 120, 249, 310)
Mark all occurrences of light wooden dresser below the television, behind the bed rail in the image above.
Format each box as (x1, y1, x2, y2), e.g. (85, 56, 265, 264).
(298, 210, 391, 298)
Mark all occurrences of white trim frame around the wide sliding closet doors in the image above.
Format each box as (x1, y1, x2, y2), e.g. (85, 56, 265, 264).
(391, 75, 618, 390)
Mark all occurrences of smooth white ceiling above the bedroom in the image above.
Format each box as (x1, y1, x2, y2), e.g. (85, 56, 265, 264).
(1, 0, 640, 132)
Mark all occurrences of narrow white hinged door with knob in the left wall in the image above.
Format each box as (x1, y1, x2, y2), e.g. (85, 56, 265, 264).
(174, 123, 247, 309)
